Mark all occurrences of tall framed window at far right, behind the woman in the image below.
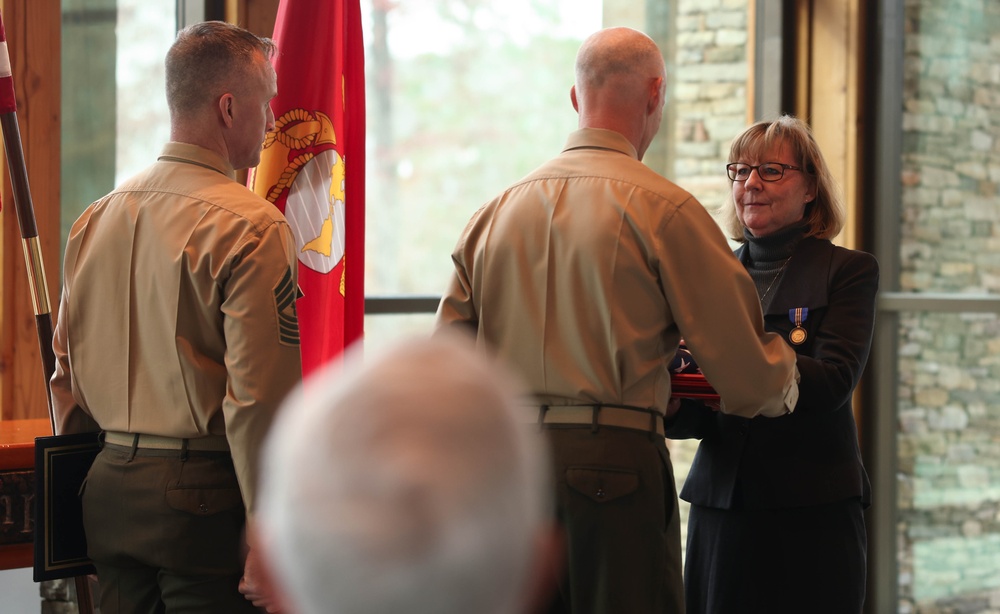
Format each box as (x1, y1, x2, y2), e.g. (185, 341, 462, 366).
(869, 0, 1000, 612)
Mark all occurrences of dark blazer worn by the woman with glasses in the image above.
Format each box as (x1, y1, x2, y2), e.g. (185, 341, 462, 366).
(667, 238, 879, 509)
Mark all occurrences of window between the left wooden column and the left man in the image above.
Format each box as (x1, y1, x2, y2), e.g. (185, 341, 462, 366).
(62, 0, 177, 251)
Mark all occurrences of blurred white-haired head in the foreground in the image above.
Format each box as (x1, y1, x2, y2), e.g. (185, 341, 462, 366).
(258, 336, 558, 614)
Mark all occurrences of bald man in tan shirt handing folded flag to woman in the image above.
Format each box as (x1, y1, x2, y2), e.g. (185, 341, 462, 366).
(437, 28, 798, 614)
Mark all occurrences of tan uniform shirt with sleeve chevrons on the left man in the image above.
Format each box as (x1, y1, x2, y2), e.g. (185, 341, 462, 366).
(52, 143, 302, 510)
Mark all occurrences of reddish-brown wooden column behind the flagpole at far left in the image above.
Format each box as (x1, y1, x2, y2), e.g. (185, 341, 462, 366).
(0, 0, 61, 420)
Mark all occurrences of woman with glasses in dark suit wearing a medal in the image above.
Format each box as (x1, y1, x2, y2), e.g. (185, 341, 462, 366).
(667, 116, 879, 614)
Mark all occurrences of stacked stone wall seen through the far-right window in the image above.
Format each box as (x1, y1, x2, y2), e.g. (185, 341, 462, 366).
(897, 0, 1000, 614)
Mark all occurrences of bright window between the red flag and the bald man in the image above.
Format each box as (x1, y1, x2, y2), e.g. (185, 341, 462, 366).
(362, 0, 601, 346)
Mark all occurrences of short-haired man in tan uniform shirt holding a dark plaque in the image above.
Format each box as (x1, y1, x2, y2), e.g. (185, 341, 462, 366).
(51, 22, 301, 614)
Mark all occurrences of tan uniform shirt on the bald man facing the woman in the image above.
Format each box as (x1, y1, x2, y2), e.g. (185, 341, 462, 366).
(437, 129, 798, 417)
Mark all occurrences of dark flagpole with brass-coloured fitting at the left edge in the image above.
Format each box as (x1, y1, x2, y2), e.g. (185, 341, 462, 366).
(0, 18, 94, 614)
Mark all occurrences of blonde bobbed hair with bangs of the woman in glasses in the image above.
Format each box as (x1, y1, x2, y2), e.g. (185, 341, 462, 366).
(719, 115, 845, 243)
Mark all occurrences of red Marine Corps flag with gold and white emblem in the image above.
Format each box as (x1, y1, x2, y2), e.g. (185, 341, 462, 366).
(249, 0, 365, 374)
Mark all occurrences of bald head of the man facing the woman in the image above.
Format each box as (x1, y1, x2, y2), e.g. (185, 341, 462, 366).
(571, 28, 666, 158)
